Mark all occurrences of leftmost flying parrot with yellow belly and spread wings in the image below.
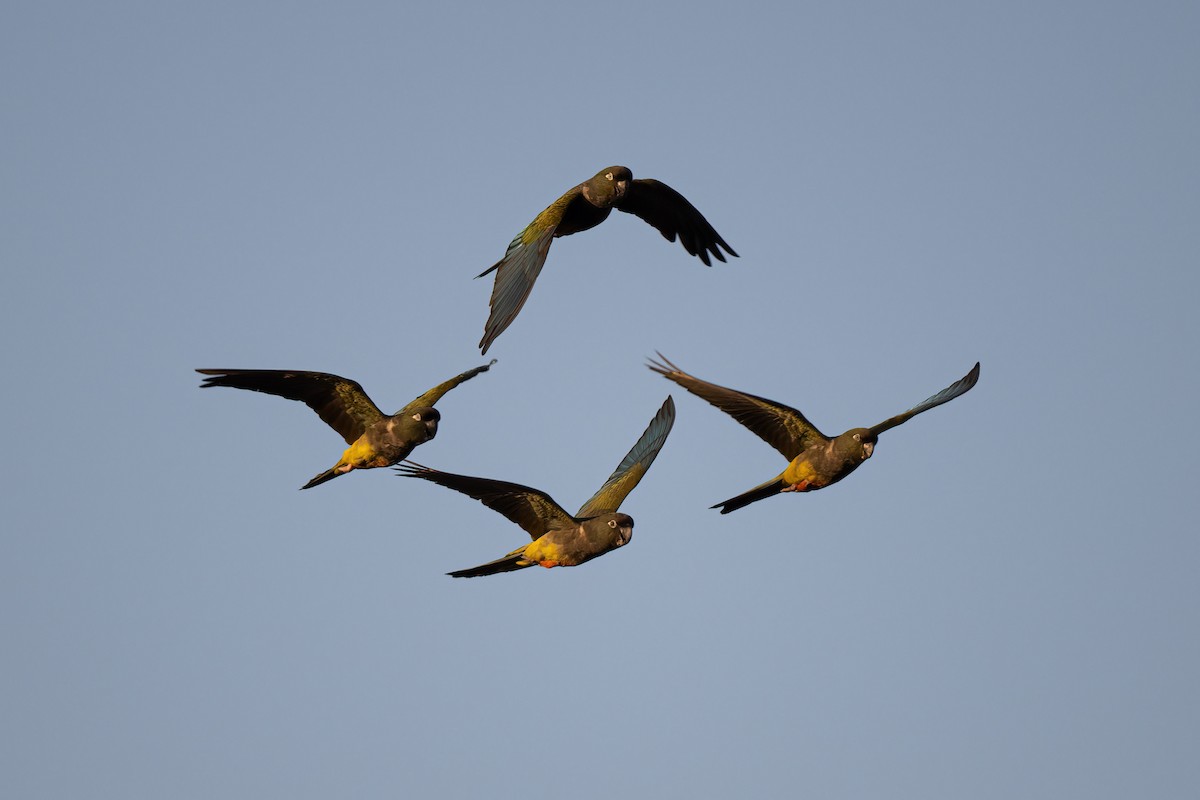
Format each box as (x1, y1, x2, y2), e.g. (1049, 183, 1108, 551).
(196, 359, 496, 489)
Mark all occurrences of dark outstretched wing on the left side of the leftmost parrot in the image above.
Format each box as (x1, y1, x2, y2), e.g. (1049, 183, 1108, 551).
(196, 369, 384, 444)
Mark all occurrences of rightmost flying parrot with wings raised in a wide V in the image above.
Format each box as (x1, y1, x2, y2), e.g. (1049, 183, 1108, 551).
(648, 353, 979, 513)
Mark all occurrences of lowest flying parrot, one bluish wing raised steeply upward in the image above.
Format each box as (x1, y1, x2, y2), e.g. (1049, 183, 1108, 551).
(396, 397, 674, 578)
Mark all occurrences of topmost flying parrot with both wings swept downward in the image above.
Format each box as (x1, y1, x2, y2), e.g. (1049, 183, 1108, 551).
(475, 167, 737, 353)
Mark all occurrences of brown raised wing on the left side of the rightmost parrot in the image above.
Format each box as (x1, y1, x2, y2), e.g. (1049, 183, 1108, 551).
(647, 353, 829, 461)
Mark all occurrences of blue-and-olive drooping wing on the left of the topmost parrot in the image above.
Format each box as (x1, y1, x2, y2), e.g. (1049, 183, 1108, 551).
(475, 186, 581, 354)
